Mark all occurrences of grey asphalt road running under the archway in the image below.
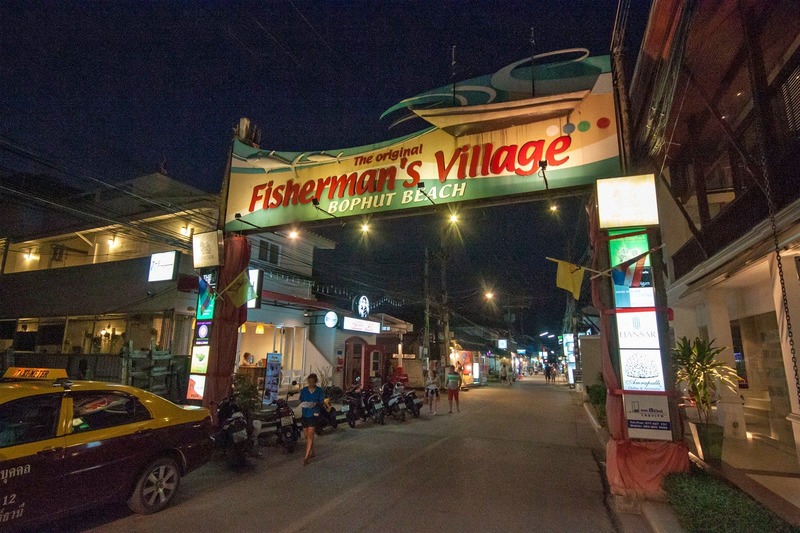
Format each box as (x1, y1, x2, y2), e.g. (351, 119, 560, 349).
(48, 377, 632, 533)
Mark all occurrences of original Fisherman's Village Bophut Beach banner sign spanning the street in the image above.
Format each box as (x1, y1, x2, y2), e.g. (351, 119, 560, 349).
(223, 49, 620, 233)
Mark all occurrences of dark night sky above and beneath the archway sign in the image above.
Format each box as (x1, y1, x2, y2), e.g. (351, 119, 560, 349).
(0, 0, 648, 340)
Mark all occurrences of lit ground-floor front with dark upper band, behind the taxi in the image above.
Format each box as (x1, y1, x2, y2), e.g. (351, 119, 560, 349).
(0, 252, 196, 399)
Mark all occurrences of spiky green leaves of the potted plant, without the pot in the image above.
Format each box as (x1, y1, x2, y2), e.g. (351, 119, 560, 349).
(672, 337, 739, 424)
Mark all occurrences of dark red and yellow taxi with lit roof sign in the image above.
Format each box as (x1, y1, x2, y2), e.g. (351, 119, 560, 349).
(0, 368, 213, 530)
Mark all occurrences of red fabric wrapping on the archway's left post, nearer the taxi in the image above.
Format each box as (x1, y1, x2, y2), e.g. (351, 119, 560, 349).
(203, 235, 250, 416)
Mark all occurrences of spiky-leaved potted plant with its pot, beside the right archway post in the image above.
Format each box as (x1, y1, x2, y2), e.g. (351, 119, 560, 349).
(672, 337, 738, 464)
